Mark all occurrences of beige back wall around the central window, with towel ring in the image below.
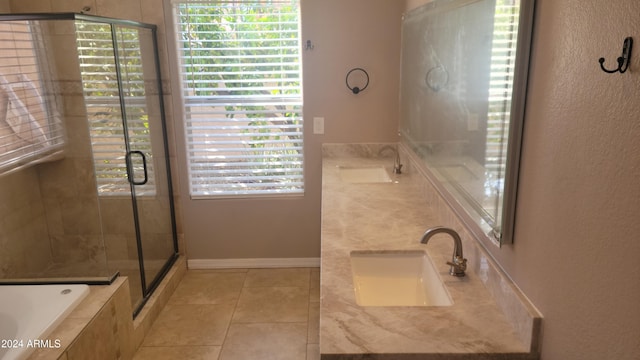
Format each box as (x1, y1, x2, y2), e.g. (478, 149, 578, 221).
(167, 0, 402, 259)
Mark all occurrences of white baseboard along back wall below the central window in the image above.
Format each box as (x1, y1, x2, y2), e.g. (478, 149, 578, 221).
(187, 258, 320, 270)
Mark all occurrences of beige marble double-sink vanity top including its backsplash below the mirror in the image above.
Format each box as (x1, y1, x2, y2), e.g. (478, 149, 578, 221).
(320, 144, 541, 360)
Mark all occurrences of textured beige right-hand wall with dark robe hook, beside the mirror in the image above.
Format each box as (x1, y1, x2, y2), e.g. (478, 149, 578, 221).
(408, 0, 640, 360)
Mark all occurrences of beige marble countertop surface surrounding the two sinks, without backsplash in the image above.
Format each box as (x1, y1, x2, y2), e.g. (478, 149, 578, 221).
(320, 144, 537, 360)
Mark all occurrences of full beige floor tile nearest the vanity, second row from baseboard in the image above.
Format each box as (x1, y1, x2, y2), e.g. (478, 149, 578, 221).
(233, 287, 309, 323)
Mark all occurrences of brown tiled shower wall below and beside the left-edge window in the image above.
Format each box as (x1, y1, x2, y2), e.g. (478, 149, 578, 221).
(0, 17, 106, 278)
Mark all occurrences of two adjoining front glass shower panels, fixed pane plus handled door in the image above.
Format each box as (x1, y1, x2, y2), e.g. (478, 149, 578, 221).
(76, 21, 177, 311)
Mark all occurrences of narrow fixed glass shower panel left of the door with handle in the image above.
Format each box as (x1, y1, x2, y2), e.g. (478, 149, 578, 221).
(75, 21, 143, 305)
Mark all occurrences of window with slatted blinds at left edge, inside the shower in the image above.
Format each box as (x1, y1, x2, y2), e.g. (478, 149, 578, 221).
(0, 21, 64, 174)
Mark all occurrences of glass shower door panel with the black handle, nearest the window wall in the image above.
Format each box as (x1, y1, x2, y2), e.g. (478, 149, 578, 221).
(114, 25, 177, 295)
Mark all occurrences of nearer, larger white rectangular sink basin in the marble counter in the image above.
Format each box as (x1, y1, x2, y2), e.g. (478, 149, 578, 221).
(351, 251, 453, 306)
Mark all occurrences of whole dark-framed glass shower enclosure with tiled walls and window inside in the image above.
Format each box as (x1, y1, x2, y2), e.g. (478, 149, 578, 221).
(0, 13, 178, 313)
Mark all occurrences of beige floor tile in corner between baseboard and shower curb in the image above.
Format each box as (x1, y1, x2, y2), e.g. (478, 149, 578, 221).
(169, 270, 246, 304)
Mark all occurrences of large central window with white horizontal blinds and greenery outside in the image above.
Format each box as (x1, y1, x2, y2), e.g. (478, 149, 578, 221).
(174, 0, 304, 198)
